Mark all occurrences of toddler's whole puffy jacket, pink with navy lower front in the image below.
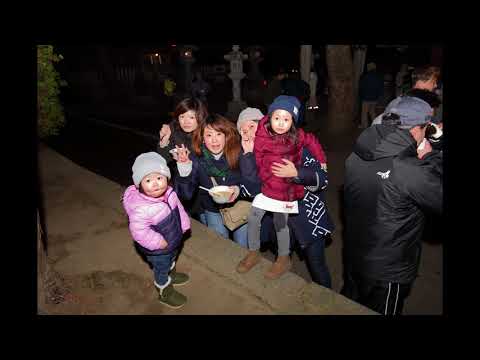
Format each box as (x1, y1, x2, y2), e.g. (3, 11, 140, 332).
(123, 185, 190, 255)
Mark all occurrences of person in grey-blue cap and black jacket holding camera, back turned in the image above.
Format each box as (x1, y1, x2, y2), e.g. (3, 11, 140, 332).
(342, 96, 443, 315)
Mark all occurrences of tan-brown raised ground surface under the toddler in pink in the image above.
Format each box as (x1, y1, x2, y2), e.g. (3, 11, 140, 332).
(39, 146, 375, 315)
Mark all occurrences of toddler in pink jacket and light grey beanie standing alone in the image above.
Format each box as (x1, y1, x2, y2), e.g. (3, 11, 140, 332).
(123, 152, 190, 309)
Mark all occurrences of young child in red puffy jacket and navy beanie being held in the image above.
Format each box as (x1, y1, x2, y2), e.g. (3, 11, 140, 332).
(237, 95, 327, 279)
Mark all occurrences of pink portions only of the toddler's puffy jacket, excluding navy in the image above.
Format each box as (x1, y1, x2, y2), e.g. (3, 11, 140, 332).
(123, 185, 190, 250)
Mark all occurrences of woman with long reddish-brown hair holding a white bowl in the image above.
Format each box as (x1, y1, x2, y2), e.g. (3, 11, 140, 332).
(175, 114, 259, 248)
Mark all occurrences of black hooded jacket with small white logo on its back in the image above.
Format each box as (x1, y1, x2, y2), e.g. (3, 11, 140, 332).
(344, 125, 443, 284)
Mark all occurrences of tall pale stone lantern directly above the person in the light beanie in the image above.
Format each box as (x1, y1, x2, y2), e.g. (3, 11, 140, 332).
(224, 45, 248, 121)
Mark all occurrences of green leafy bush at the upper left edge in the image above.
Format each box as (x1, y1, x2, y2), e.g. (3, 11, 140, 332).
(37, 45, 67, 138)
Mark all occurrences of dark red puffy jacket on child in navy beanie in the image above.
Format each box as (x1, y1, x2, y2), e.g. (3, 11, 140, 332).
(253, 115, 327, 201)
